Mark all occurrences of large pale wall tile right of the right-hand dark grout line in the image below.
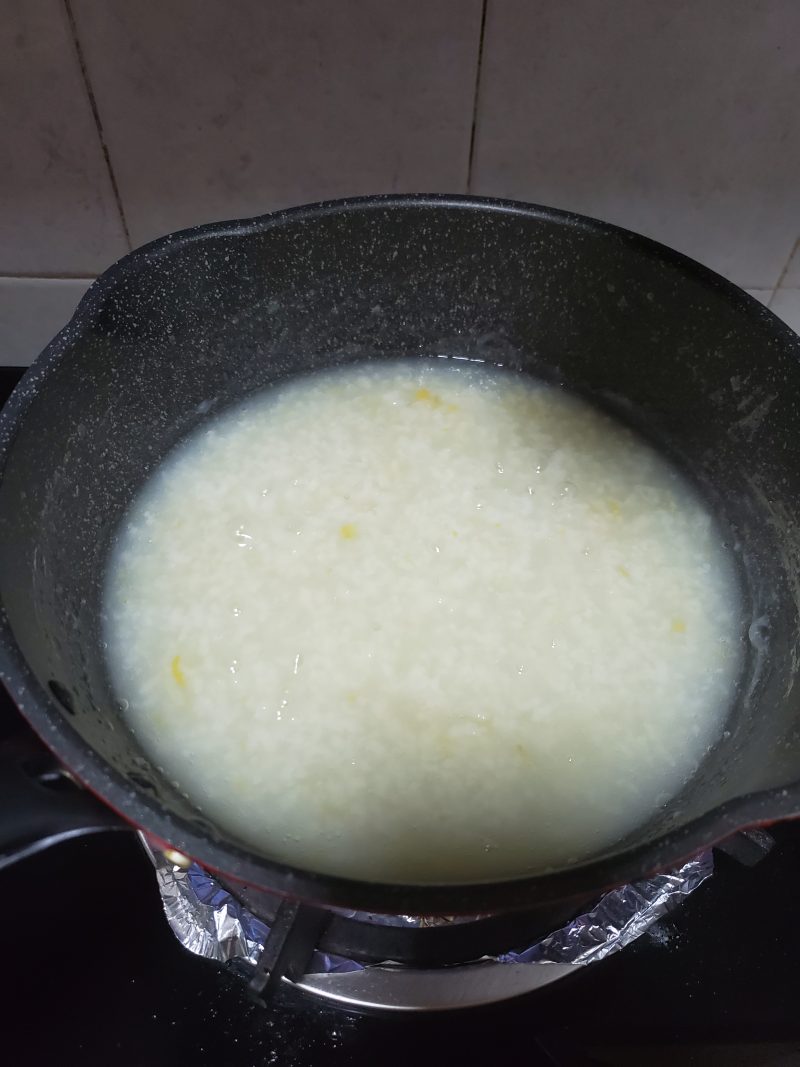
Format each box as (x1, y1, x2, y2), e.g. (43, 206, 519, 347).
(473, 0, 800, 288)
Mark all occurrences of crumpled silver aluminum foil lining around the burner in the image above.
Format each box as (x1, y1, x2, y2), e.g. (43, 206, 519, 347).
(145, 843, 714, 974)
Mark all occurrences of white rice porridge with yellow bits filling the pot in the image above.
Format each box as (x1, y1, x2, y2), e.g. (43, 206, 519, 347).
(105, 360, 740, 883)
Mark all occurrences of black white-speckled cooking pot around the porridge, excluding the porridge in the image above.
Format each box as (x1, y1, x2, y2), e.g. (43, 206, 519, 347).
(0, 196, 800, 914)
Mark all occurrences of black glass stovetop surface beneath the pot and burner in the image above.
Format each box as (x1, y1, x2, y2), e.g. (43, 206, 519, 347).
(0, 368, 800, 1067)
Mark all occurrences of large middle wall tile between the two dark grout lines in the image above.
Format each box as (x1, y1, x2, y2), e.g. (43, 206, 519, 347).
(73, 0, 481, 243)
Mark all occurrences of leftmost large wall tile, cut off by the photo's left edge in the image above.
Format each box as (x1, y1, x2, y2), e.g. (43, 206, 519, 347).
(0, 0, 127, 275)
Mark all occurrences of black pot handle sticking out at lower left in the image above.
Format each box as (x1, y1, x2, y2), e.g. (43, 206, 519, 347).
(0, 729, 130, 870)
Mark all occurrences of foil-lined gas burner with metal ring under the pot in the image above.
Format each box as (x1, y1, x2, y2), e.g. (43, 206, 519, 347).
(144, 841, 725, 1012)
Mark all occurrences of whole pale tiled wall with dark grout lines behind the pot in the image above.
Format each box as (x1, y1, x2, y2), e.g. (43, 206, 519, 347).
(0, 0, 800, 362)
